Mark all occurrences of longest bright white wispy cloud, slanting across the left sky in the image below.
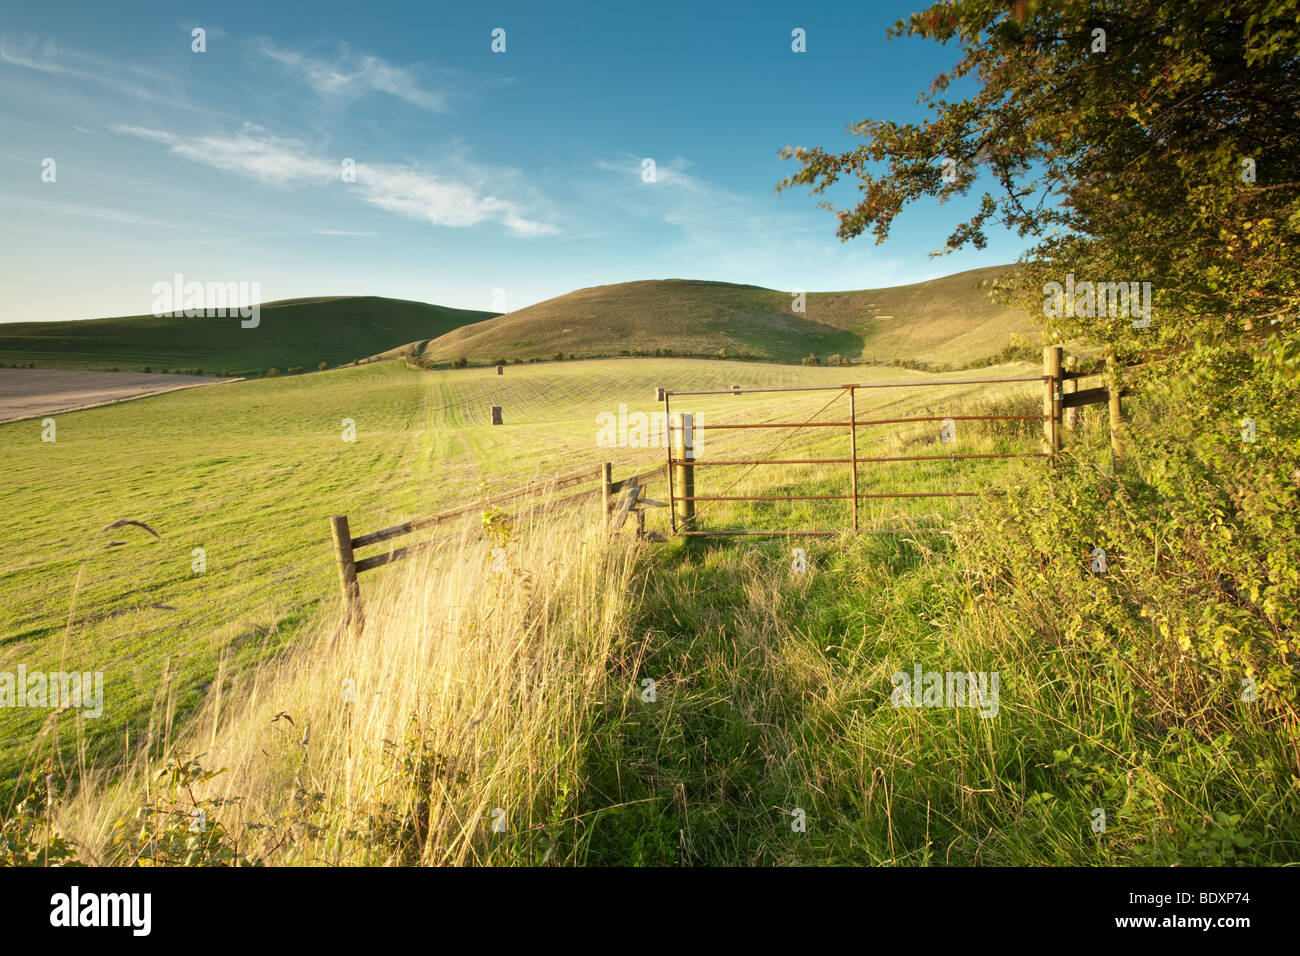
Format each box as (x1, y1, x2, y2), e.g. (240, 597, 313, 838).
(114, 125, 558, 237)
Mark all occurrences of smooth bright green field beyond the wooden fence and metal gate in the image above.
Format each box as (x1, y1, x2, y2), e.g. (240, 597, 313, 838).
(0, 359, 1032, 785)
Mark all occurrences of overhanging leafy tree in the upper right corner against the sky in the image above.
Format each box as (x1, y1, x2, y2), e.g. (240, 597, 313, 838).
(781, 0, 1300, 351)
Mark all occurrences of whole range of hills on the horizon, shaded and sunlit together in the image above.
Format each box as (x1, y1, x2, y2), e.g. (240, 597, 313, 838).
(0, 267, 1037, 375)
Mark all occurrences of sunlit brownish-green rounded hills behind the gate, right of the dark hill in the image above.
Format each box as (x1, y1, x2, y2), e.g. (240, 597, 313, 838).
(400, 265, 1039, 367)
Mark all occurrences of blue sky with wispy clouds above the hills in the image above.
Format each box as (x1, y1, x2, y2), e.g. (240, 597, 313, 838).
(0, 0, 1024, 321)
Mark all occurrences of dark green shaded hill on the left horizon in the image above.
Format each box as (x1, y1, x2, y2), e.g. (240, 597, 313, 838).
(0, 295, 493, 375)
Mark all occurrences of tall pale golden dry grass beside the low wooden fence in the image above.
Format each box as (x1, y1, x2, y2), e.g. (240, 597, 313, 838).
(59, 514, 638, 865)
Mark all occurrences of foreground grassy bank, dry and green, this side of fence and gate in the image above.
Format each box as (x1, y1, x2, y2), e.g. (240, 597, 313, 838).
(22, 468, 1300, 865)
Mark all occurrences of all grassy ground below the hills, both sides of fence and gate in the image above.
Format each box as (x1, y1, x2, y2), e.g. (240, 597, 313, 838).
(0, 359, 1300, 865)
